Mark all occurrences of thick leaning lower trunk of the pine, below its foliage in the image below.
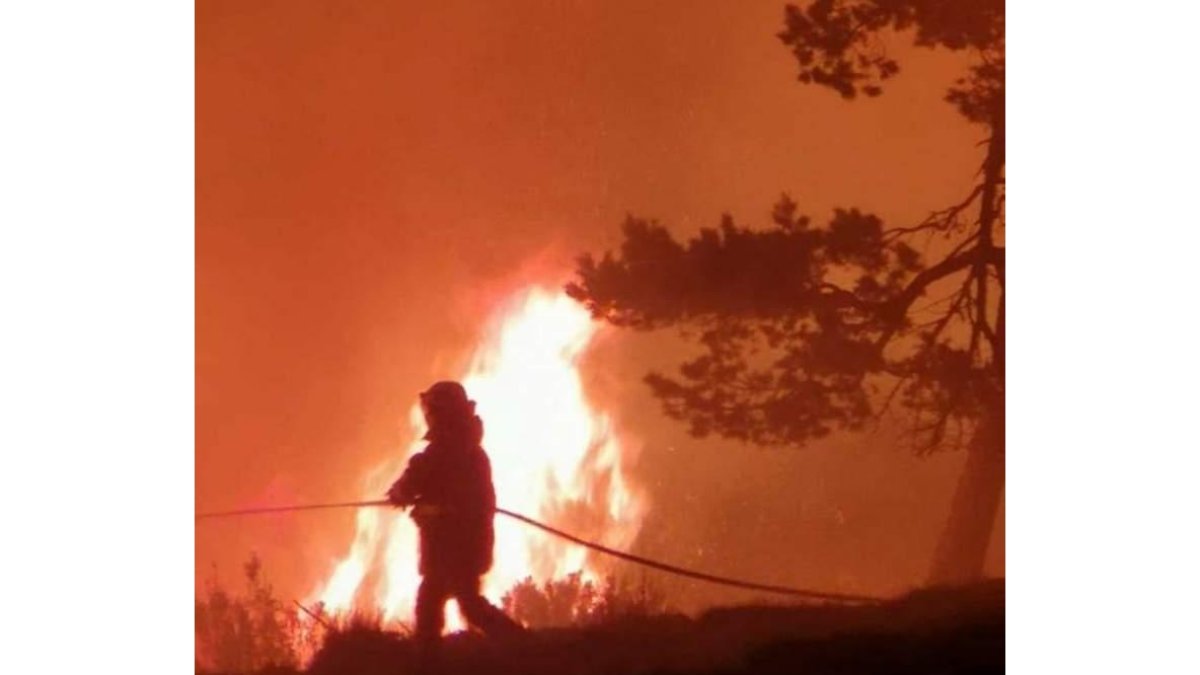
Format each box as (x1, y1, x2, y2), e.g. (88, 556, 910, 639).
(929, 411, 1004, 585)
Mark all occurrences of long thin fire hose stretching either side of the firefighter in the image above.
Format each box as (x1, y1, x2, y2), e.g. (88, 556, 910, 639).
(196, 500, 883, 604)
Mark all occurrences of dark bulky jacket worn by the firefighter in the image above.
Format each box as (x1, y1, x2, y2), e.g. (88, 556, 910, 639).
(389, 416, 496, 578)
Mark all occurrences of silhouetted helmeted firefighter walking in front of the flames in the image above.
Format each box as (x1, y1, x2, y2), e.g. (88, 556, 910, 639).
(388, 382, 523, 641)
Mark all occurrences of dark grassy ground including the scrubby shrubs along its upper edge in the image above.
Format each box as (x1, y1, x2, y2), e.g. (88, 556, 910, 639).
(197, 554, 1004, 675)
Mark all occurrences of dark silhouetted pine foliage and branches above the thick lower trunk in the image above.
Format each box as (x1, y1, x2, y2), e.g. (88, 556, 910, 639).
(568, 0, 1004, 452)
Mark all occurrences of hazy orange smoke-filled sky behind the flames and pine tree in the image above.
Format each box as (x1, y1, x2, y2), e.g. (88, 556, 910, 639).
(196, 0, 1003, 603)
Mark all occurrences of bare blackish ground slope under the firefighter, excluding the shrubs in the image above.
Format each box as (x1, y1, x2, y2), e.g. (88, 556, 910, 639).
(220, 580, 1004, 675)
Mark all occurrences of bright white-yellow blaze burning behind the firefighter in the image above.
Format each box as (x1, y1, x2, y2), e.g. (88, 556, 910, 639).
(310, 282, 647, 629)
